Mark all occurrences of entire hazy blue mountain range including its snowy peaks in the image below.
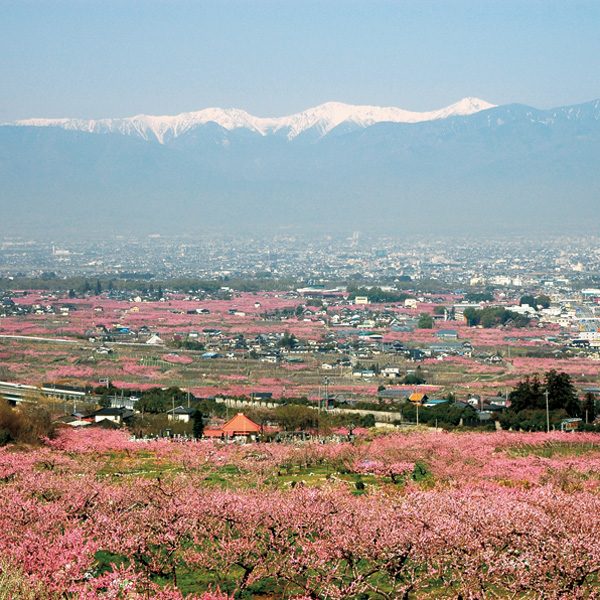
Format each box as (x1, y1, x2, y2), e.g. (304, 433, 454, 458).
(0, 98, 600, 236)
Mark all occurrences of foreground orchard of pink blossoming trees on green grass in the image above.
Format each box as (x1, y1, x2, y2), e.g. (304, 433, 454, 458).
(0, 431, 600, 600)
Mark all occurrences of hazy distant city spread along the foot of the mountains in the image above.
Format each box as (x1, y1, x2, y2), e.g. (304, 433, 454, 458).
(0, 232, 600, 288)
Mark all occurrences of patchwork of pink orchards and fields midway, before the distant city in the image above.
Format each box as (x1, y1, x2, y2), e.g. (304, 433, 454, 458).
(0, 293, 600, 400)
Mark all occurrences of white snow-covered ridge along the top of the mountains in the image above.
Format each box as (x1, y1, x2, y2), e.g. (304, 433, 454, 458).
(12, 98, 495, 144)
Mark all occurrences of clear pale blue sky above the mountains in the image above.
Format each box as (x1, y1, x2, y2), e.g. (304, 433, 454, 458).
(0, 0, 600, 123)
